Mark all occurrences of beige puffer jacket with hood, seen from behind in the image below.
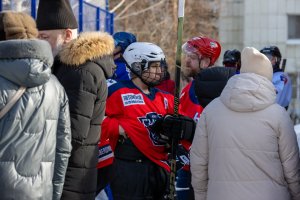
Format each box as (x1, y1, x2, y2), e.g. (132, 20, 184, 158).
(191, 73, 300, 200)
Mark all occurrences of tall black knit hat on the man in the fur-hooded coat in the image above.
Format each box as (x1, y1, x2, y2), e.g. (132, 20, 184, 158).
(36, 0, 78, 30)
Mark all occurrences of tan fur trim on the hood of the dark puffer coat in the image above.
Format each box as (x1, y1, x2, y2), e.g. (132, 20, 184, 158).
(59, 32, 115, 66)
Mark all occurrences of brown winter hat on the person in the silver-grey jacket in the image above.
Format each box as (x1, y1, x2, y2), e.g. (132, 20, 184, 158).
(0, 11, 38, 41)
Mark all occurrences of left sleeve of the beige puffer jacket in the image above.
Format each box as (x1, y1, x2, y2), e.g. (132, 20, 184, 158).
(190, 111, 208, 200)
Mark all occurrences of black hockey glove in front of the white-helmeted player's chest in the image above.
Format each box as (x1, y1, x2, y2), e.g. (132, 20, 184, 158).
(149, 115, 196, 142)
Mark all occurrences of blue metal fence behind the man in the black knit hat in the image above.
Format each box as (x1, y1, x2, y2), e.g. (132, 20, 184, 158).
(0, 0, 114, 34)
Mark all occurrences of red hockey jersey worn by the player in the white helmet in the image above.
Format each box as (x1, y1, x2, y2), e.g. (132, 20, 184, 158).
(101, 80, 174, 170)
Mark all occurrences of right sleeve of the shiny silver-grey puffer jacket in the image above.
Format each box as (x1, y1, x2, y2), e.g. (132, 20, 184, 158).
(52, 92, 72, 200)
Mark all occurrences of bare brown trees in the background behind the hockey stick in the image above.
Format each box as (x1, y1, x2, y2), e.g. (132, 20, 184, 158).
(110, 0, 220, 78)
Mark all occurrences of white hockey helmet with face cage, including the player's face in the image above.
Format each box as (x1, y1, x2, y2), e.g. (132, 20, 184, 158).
(123, 42, 167, 87)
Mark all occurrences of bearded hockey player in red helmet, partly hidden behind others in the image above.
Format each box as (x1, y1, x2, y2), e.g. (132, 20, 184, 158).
(176, 36, 221, 200)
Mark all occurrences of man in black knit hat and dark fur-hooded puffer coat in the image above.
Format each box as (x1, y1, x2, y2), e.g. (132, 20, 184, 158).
(37, 0, 115, 200)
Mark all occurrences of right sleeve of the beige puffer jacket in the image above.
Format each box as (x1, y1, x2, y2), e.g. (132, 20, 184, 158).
(278, 110, 300, 200)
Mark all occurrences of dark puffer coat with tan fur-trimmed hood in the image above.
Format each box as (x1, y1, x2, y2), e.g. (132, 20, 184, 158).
(53, 32, 114, 200)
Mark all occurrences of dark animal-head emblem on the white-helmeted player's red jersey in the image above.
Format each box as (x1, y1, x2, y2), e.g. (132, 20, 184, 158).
(138, 112, 165, 146)
